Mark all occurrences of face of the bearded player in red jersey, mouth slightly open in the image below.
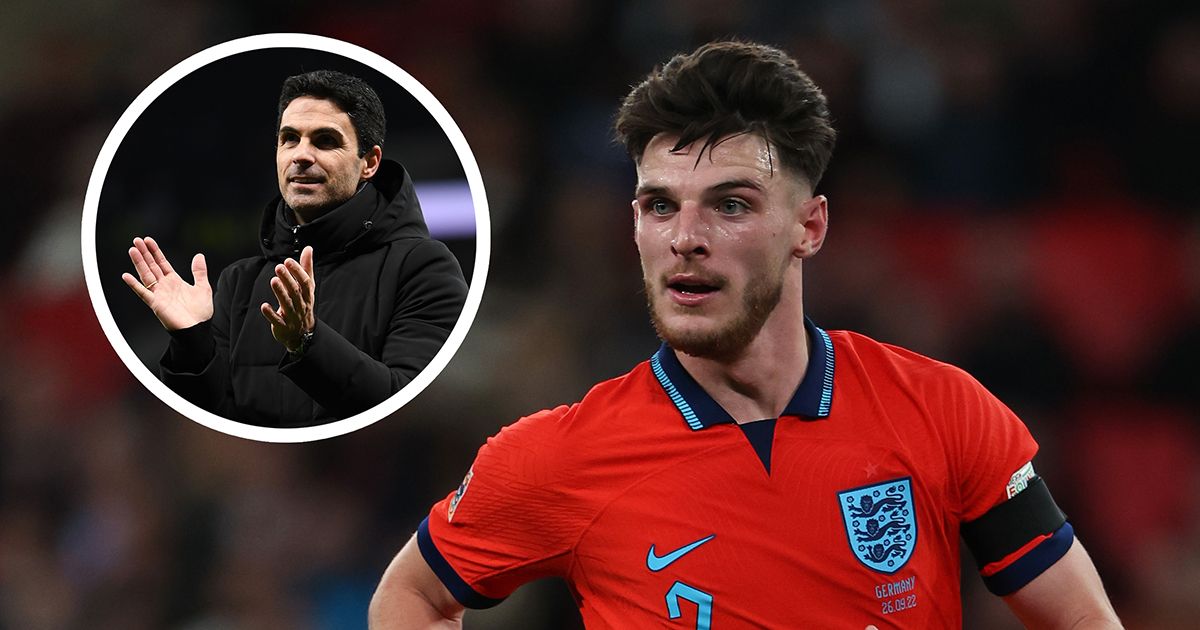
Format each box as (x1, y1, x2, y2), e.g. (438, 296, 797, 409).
(634, 133, 824, 359)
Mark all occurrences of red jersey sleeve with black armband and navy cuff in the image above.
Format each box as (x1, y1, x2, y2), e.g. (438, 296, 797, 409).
(947, 364, 1074, 595)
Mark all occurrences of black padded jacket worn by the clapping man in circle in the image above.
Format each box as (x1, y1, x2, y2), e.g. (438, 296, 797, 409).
(160, 160, 467, 427)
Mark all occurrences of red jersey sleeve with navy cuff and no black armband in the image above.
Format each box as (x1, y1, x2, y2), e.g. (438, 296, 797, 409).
(416, 407, 594, 608)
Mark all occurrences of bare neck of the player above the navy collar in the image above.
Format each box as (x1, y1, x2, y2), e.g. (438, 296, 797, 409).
(677, 292, 809, 424)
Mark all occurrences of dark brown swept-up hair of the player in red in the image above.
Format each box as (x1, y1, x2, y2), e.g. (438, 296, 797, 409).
(616, 41, 836, 186)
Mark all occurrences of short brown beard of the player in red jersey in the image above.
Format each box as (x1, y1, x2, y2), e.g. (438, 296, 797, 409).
(643, 265, 784, 360)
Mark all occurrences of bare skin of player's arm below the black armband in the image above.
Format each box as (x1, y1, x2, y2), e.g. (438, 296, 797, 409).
(1004, 539, 1121, 630)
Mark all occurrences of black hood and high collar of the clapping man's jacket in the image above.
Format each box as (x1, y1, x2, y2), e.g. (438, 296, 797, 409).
(259, 160, 430, 264)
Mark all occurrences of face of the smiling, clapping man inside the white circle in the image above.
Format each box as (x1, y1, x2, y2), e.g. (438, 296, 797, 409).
(275, 96, 378, 222)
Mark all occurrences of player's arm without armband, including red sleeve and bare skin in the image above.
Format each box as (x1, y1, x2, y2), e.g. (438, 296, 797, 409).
(370, 407, 578, 630)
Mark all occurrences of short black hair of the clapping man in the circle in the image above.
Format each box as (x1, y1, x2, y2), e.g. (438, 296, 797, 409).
(275, 70, 388, 157)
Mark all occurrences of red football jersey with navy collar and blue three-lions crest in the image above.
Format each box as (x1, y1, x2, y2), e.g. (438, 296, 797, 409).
(418, 322, 1069, 629)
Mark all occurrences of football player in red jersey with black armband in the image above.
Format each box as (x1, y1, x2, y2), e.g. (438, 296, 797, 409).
(371, 42, 1120, 630)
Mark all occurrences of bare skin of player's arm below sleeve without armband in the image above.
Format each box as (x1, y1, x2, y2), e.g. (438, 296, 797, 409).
(368, 536, 463, 630)
